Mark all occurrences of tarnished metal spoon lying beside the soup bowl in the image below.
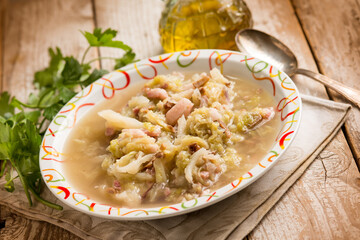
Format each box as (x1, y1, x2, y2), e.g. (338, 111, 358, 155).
(235, 29, 360, 108)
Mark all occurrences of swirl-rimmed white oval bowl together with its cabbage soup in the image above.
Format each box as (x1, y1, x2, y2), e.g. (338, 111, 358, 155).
(40, 50, 301, 220)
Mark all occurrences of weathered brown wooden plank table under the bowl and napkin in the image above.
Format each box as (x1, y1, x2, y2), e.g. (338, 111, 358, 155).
(0, 0, 360, 240)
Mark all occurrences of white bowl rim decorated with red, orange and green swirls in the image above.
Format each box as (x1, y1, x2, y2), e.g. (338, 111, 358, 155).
(40, 50, 302, 220)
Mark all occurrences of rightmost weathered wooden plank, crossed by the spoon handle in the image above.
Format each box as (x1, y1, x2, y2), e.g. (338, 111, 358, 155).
(292, 0, 360, 168)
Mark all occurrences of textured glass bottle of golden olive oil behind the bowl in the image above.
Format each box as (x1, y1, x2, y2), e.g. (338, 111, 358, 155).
(159, 0, 252, 52)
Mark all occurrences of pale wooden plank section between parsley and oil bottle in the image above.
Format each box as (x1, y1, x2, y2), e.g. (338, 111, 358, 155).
(95, 0, 164, 69)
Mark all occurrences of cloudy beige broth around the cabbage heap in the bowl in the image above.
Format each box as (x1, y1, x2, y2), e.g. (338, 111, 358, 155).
(63, 72, 280, 207)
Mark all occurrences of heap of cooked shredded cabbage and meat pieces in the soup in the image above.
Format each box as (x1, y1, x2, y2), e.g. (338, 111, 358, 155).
(99, 68, 274, 203)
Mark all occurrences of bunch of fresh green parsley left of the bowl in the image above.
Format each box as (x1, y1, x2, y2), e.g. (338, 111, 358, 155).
(0, 28, 135, 210)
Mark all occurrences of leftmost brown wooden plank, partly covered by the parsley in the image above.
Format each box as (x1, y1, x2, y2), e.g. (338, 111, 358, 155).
(0, 0, 97, 240)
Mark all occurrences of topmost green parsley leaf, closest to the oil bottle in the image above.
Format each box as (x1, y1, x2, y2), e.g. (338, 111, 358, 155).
(81, 28, 131, 51)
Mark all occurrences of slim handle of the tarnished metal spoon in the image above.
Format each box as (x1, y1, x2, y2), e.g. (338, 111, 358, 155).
(296, 68, 360, 108)
